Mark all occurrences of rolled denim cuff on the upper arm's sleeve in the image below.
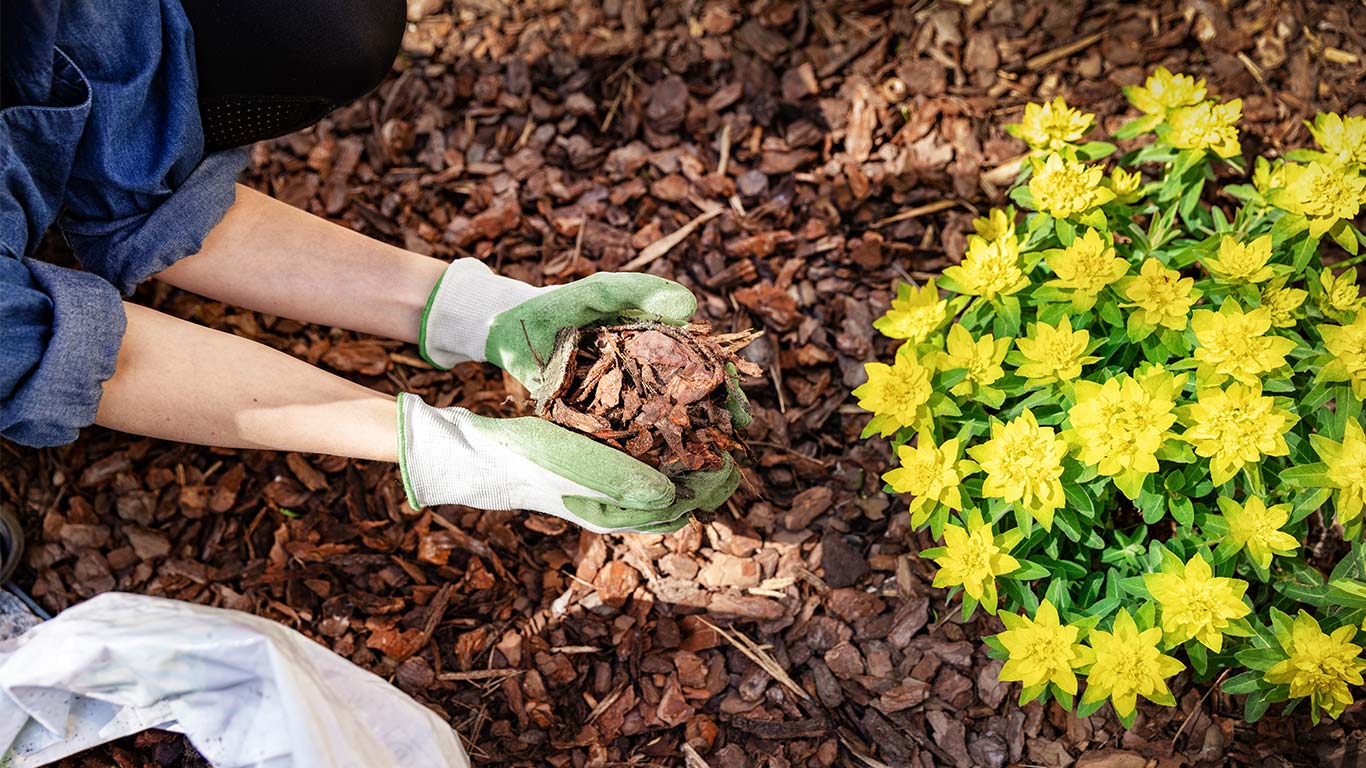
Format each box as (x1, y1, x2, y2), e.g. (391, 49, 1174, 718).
(61, 148, 247, 295)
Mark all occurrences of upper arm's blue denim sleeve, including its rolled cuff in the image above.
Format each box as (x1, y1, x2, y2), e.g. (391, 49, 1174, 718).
(57, 0, 247, 294)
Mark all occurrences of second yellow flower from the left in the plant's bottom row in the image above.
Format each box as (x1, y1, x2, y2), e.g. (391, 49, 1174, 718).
(1082, 608, 1186, 717)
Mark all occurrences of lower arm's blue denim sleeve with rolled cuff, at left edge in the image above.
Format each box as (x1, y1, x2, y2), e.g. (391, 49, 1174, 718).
(0, 38, 124, 445)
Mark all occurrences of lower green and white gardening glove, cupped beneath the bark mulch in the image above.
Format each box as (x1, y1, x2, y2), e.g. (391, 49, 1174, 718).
(399, 394, 739, 533)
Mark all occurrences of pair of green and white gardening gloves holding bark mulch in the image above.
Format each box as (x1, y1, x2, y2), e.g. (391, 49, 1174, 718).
(399, 258, 749, 533)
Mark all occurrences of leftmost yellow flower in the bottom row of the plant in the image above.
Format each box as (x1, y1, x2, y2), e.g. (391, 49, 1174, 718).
(996, 597, 1093, 696)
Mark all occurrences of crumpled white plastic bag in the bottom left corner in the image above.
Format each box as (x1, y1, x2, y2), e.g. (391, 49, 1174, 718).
(0, 593, 470, 768)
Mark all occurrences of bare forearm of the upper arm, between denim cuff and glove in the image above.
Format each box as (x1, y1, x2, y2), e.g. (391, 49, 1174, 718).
(157, 186, 445, 342)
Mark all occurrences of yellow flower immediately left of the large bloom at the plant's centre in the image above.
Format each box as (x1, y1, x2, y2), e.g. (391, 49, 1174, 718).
(967, 409, 1067, 530)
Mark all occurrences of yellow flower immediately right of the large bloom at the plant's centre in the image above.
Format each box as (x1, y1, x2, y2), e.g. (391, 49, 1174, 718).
(1180, 383, 1291, 485)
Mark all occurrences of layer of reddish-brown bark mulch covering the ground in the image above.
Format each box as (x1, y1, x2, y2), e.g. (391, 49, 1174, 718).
(0, 0, 1366, 768)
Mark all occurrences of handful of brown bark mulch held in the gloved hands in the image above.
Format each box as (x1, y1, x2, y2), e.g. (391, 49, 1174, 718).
(535, 323, 762, 474)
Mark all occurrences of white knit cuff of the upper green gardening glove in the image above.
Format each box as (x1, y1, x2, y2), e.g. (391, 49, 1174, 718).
(418, 258, 546, 370)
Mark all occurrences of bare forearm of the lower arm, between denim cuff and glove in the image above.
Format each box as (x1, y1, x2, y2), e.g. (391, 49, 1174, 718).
(96, 303, 398, 462)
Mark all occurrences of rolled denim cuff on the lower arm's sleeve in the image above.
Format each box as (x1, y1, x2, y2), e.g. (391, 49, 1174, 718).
(0, 258, 127, 447)
